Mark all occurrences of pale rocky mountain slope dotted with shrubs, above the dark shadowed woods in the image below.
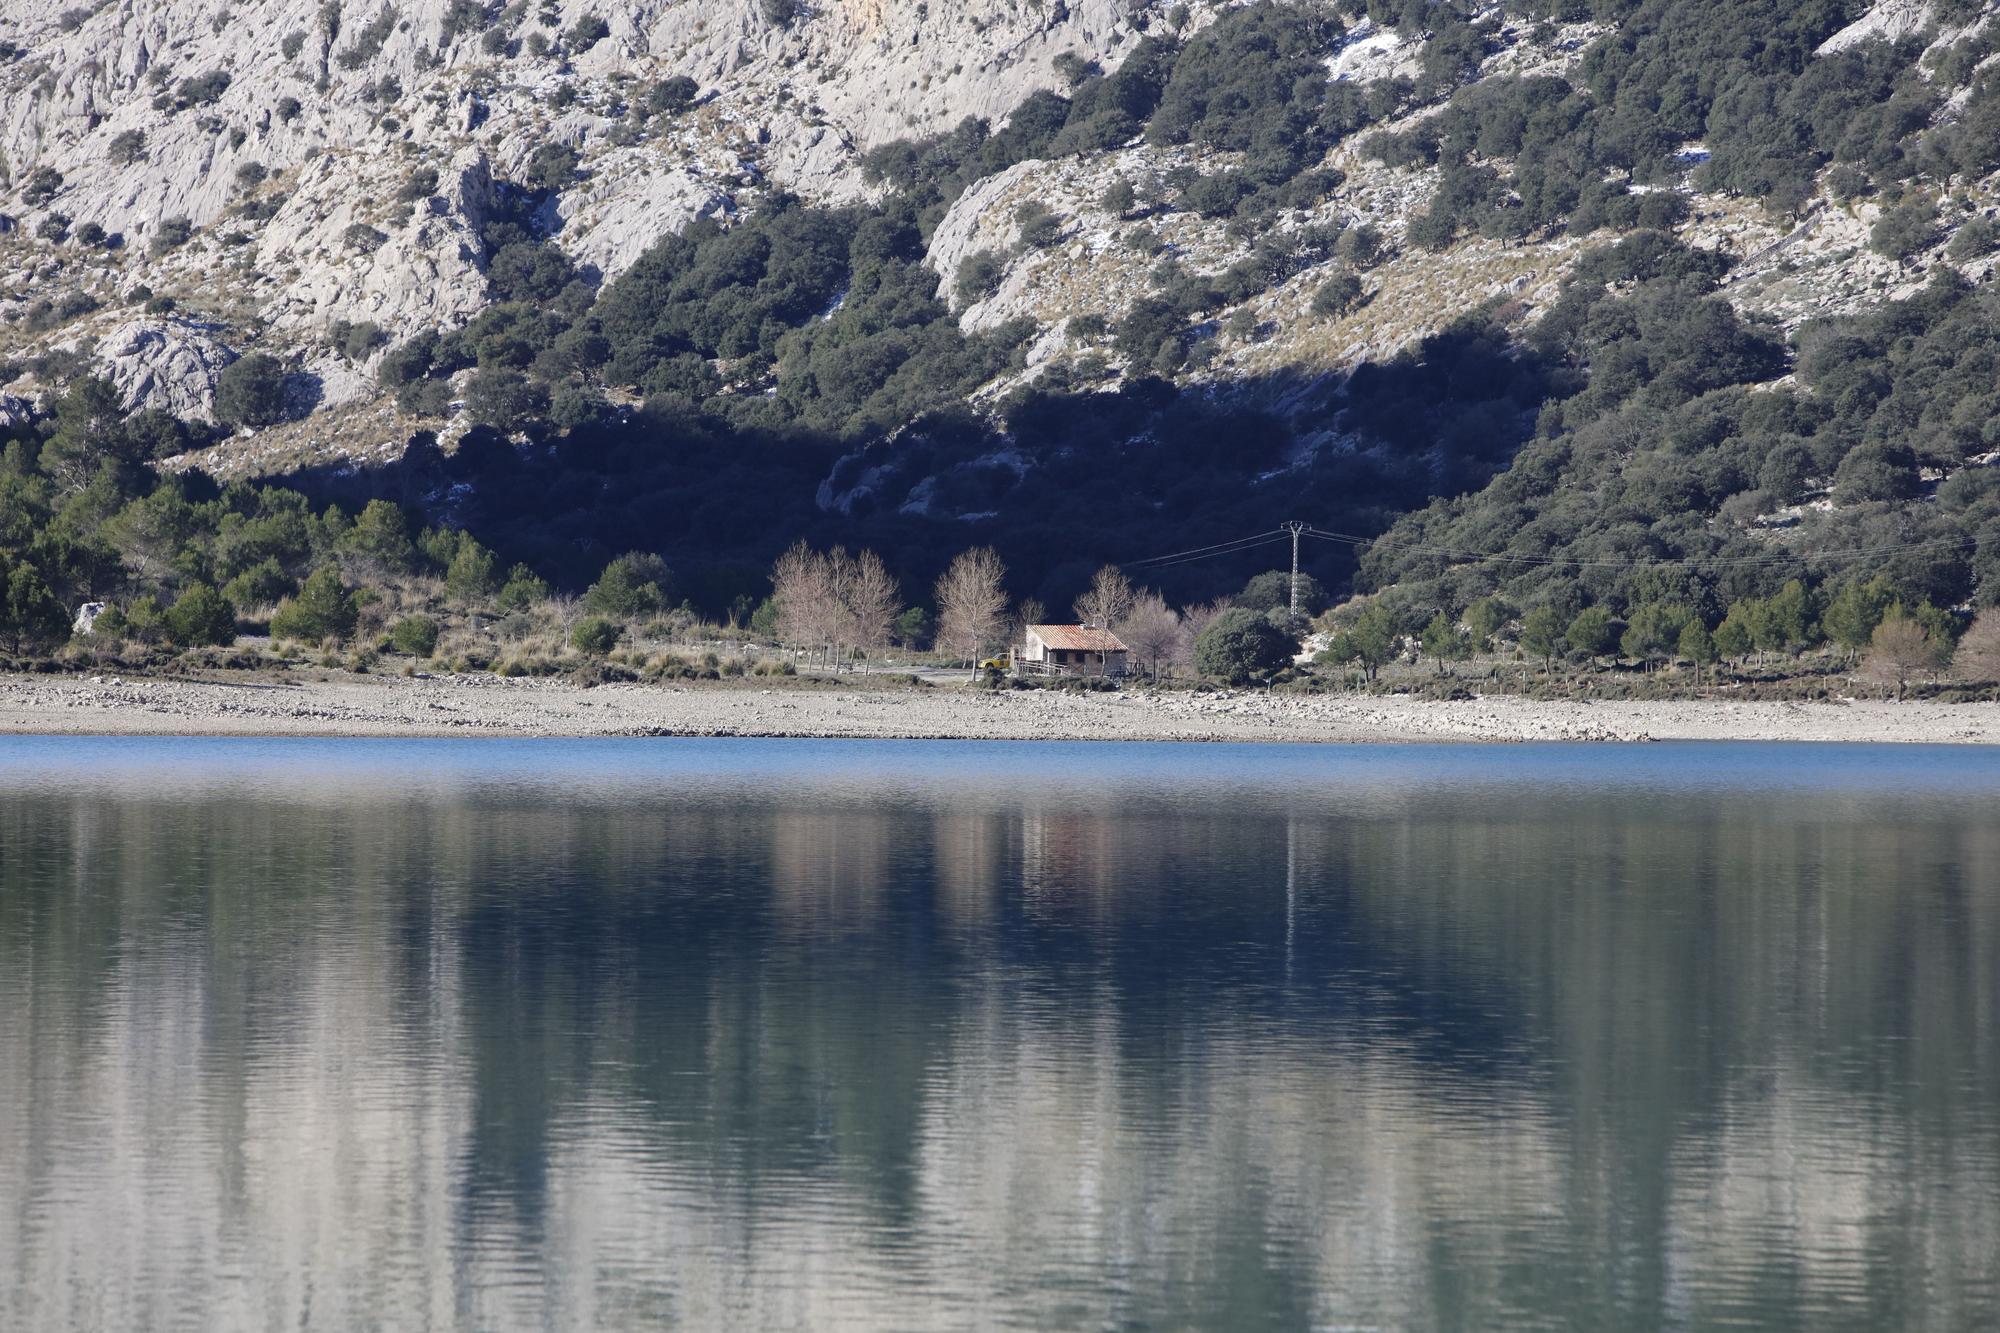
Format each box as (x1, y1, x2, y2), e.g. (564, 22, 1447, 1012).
(0, 0, 2000, 608)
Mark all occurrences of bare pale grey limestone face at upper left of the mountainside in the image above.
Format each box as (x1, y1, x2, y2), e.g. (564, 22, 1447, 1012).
(0, 0, 1166, 370)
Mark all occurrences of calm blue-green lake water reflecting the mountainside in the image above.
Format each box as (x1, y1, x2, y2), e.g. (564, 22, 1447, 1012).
(0, 739, 2000, 1331)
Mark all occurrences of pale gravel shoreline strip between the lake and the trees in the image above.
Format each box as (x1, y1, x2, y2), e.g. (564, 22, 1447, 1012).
(0, 675, 2000, 745)
